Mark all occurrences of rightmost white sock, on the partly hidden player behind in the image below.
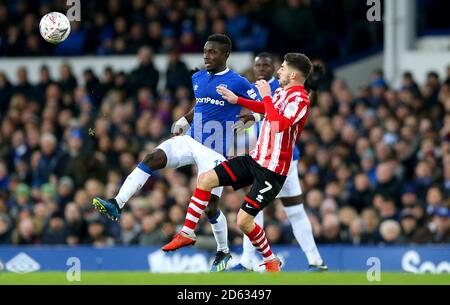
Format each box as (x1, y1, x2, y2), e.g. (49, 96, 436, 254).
(284, 204, 323, 265)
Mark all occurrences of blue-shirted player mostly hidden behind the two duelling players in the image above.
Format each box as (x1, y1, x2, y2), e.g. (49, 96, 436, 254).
(231, 53, 328, 271)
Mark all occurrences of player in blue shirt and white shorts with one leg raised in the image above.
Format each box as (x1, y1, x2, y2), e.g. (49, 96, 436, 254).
(92, 34, 256, 272)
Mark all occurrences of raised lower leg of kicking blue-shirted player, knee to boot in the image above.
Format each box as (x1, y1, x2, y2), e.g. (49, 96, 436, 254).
(92, 149, 167, 220)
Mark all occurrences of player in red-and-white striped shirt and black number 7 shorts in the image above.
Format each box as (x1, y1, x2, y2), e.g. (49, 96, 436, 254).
(164, 53, 312, 272)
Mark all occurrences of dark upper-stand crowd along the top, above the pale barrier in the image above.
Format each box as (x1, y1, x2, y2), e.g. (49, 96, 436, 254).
(0, 0, 382, 60)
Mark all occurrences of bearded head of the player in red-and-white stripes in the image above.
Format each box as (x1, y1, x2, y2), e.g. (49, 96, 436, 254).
(277, 53, 312, 87)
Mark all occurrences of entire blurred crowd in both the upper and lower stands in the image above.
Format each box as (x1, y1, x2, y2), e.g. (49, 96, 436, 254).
(0, 0, 450, 248)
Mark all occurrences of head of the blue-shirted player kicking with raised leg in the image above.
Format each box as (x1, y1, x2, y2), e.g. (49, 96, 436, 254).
(203, 34, 231, 73)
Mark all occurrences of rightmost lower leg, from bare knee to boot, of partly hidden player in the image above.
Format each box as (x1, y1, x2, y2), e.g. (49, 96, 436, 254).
(281, 195, 328, 272)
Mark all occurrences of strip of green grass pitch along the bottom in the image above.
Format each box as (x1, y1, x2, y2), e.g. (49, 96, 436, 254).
(0, 272, 450, 285)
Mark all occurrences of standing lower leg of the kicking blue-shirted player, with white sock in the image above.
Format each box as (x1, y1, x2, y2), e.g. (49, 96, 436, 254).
(205, 195, 231, 272)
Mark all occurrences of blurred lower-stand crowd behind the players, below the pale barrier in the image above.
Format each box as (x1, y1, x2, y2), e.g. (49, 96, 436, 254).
(0, 48, 450, 245)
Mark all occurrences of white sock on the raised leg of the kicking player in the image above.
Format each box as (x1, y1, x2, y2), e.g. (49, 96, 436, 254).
(114, 162, 152, 208)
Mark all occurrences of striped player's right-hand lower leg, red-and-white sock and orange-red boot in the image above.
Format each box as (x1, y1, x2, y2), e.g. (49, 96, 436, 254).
(237, 209, 281, 272)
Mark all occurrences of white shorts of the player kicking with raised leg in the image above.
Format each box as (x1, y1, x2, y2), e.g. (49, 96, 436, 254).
(157, 135, 225, 197)
